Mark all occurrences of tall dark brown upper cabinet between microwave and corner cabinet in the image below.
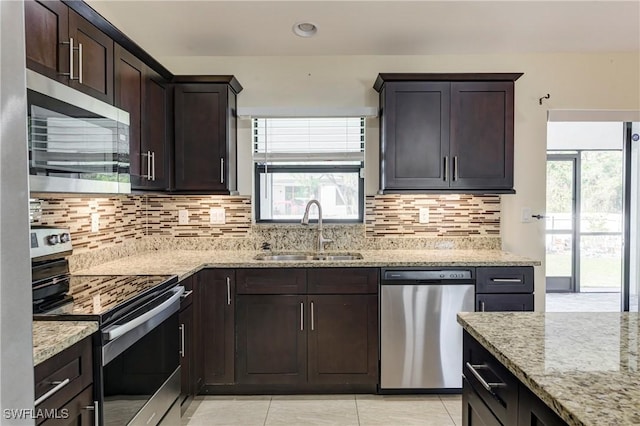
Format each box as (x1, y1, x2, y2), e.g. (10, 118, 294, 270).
(115, 44, 171, 190)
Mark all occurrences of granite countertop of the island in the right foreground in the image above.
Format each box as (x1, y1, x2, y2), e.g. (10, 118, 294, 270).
(458, 312, 640, 425)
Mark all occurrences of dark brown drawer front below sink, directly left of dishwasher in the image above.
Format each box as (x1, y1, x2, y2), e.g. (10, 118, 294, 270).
(307, 268, 378, 294)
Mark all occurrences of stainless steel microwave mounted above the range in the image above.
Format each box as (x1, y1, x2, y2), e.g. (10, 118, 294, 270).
(27, 70, 131, 194)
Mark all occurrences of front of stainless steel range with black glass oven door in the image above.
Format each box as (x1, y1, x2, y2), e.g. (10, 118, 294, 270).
(101, 286, 184, 426)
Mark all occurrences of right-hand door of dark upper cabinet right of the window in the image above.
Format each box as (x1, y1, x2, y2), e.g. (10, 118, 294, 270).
(450, 82, 513, 189)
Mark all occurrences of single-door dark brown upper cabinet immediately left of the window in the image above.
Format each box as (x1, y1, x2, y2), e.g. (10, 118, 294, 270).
(172, 76, 242, 194)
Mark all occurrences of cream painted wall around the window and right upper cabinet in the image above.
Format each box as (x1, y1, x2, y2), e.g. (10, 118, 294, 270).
(158, 52, 640, 310)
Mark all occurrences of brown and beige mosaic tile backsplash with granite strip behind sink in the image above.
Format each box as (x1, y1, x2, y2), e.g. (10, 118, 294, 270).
(32, 194, 500, 260)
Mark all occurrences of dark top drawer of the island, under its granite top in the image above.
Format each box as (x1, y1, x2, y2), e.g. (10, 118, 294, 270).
(462, 331, 519, 425)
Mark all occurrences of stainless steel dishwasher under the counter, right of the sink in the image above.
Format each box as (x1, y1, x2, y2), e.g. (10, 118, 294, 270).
(380, 268, 475, 393)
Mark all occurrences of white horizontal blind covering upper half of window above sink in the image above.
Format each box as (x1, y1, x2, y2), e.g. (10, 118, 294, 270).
(253, 117, 365, 164)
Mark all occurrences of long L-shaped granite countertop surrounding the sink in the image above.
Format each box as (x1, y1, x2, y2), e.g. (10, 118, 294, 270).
(74, 250, 540, 279)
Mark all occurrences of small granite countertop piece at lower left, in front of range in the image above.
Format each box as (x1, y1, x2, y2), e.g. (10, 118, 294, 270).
(33, 321, 98, 366)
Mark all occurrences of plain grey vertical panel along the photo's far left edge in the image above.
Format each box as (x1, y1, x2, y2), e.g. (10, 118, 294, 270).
(0, 1, 34, 425)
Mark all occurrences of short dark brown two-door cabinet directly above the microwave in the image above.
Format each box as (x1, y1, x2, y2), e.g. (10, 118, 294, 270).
(25, 0, 113, 104)
